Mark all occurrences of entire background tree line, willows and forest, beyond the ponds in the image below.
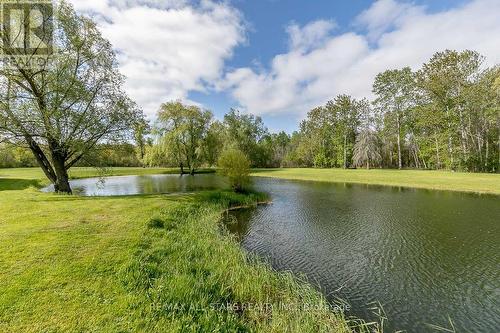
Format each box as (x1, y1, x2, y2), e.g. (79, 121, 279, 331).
(0, 50, 500, 172)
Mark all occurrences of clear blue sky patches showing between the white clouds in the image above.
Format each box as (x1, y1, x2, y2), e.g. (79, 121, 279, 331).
(189, 0, 376, 132)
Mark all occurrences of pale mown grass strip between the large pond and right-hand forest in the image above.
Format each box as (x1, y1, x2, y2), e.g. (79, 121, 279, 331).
(253, 168, 500, 194)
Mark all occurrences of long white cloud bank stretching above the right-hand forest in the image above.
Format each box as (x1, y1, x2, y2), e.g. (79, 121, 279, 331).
(225, 0, 500, 116)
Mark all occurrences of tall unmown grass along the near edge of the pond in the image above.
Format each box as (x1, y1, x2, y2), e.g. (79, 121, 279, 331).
(121, 191, 373, 332)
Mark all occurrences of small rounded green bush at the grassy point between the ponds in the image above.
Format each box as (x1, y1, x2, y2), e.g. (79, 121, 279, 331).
(217, 148, 250, 192)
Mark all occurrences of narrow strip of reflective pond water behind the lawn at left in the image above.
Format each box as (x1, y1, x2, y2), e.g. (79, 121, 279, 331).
(42, 174, 227, 196)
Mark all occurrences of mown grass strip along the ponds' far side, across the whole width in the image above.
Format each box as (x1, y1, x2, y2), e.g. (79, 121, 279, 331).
(0, 167, 500, 196)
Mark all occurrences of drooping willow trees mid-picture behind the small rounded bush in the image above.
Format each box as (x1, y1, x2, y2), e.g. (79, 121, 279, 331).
(144, 102, 291, 171)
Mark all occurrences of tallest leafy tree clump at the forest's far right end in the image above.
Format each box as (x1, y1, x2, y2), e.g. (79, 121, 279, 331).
(416, 50, 500, 171)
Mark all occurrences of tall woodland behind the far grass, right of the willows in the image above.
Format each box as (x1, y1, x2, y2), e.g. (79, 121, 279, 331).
(288, 50, 500, 172)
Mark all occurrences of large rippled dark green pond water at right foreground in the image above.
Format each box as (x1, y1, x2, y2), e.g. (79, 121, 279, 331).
(229, 178, 500, 332)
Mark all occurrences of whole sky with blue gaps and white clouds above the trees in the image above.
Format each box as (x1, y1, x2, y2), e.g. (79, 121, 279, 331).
(71, 0, 500, 132)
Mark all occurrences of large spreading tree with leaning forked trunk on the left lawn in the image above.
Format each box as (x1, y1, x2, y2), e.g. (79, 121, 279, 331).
(0, 1, 141, 193)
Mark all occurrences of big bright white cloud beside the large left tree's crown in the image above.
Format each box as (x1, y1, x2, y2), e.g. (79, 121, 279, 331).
(71, 0, 244, 116)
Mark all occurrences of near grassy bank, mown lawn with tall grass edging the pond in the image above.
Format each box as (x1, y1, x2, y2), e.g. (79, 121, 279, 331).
(0, 169, 366, 332)
